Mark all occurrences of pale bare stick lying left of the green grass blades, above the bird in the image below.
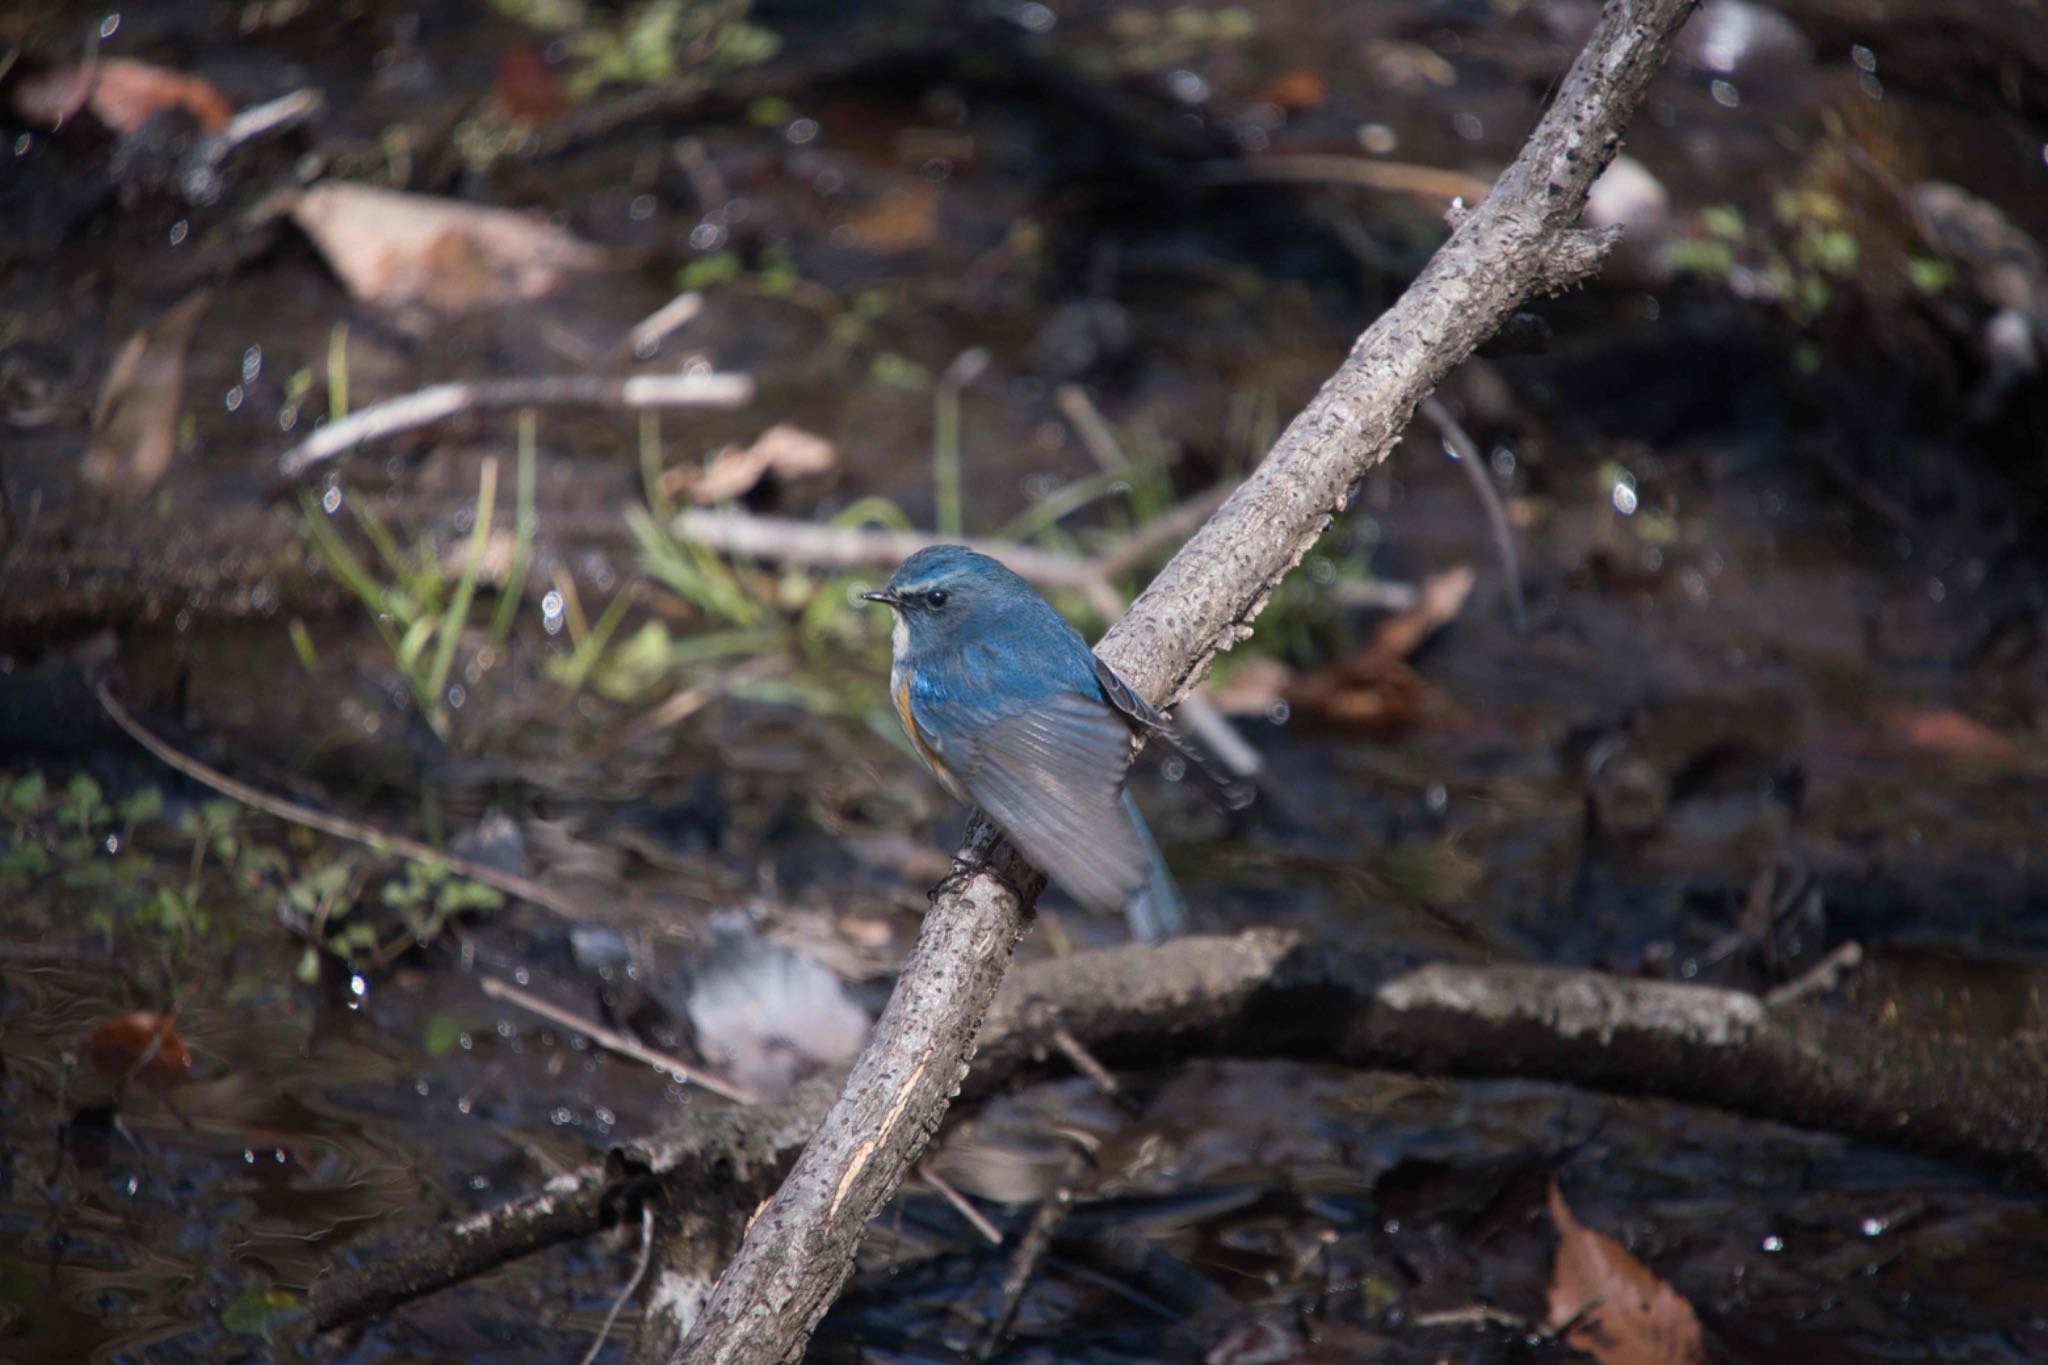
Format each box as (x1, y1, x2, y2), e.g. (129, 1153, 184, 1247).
(276, 375, 754, 481)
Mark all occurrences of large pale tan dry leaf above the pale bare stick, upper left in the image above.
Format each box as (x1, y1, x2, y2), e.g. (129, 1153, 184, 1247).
(291, 182, 627, 313)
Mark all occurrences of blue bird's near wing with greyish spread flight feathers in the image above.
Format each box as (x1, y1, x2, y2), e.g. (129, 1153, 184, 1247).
(929, 692, 1151, 913)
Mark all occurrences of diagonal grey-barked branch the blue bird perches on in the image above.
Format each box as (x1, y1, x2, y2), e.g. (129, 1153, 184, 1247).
(672, 0, 1696, 1365)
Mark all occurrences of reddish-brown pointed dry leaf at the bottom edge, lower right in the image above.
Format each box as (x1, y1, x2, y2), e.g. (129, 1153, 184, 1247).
(1550, 1181, 1706, 1365)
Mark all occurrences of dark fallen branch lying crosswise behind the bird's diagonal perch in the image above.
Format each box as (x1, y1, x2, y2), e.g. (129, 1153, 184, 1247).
(311, 929, 2048, 1328)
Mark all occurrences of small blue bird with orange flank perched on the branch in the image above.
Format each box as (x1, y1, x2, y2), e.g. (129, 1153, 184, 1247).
(864, 544, 1188, 943)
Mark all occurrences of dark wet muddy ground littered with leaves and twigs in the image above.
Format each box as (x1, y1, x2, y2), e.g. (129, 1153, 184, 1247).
(0, 0, 2048, 1363)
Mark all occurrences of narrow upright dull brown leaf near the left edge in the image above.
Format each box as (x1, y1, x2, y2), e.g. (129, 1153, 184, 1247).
(80, 289, 213, 503)
